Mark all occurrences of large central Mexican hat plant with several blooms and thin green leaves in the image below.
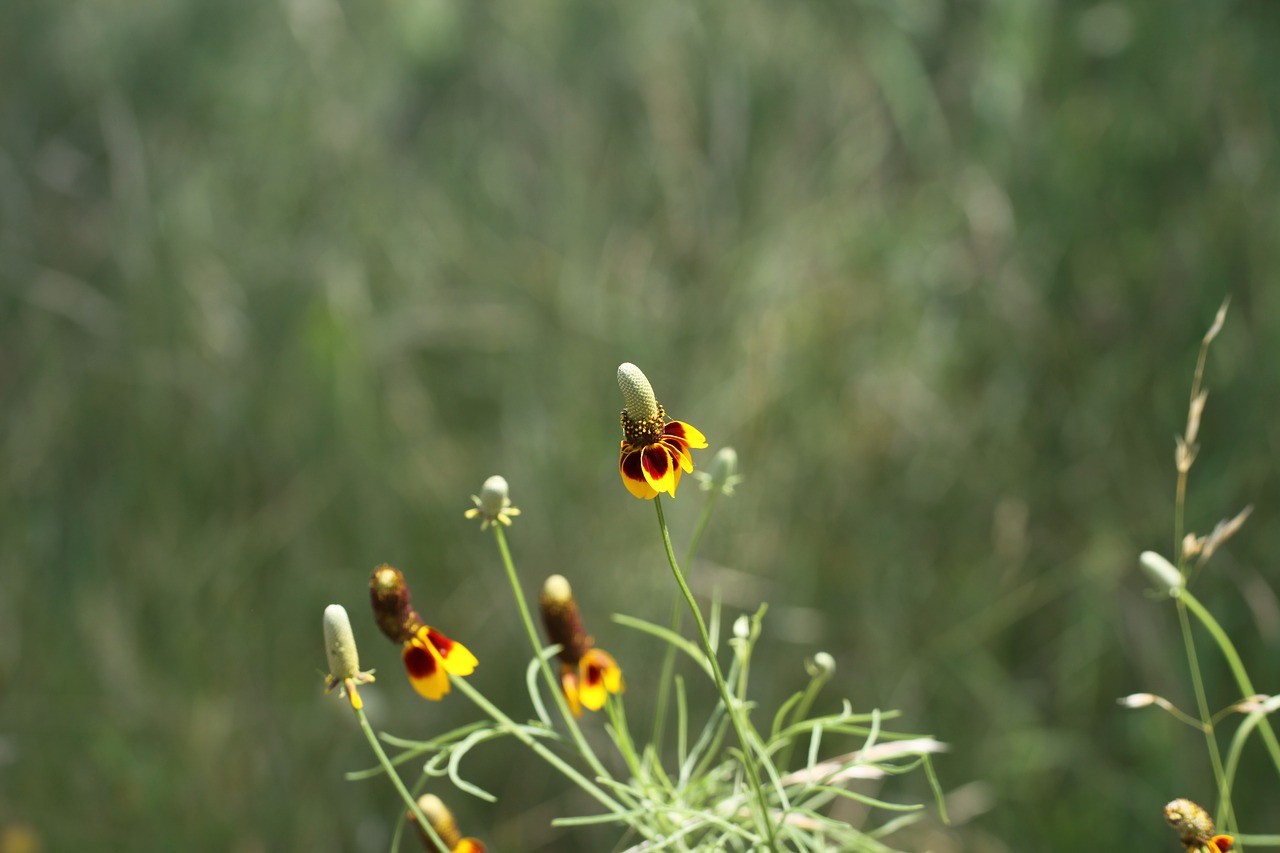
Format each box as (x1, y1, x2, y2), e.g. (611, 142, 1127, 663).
(326, 364, 946, 853)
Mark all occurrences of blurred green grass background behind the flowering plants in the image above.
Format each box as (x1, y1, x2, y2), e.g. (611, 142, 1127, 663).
(0, 0, 1280, 853)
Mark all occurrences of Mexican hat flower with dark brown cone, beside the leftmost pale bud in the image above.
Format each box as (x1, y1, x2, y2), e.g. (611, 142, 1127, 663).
(369, 564, 477, 701)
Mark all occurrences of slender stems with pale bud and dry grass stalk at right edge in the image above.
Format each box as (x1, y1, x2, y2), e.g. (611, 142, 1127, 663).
(1119, 302, 1280, 853)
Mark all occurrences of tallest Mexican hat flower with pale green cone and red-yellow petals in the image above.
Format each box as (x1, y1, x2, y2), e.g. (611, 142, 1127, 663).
(618, 362, 707, 500)
